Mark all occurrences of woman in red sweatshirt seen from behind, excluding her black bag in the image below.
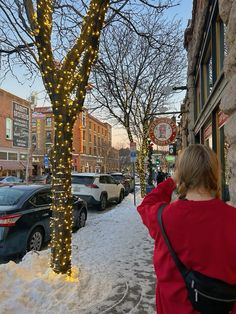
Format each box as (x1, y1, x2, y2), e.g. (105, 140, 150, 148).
(138, 144, 236, 314)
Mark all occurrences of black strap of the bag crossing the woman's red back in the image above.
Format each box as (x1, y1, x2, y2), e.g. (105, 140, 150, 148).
(157, 204, 189, 277)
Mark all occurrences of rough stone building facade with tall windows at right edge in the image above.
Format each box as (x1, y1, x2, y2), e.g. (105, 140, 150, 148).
(181, 0, 236, 203)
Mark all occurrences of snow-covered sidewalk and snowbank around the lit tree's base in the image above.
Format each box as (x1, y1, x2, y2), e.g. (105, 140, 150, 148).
(0, 189, 156, 314)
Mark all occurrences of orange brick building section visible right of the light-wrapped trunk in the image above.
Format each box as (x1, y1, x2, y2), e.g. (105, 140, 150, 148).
(72, 109, 119, 172)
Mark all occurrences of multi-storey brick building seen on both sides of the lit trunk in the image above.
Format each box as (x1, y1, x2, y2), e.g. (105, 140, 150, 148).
(32, 107, 119, 175)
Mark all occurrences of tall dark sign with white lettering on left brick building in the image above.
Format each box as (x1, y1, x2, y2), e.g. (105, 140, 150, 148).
(13, 102, 29, 148)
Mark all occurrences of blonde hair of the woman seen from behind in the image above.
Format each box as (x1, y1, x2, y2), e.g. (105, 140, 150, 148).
(176, 144, 220, 198)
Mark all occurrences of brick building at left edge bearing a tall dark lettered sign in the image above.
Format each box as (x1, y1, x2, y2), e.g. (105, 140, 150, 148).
(0, 89, 32, 179)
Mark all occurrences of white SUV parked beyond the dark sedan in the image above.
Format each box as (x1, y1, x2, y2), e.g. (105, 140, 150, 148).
(72, 173, 125, 210)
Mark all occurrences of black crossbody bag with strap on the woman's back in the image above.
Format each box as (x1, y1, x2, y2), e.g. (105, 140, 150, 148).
(157, 204, 236, 314)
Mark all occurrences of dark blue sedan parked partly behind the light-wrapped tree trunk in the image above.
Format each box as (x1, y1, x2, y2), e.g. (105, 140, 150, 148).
(0, 185, 87, 257)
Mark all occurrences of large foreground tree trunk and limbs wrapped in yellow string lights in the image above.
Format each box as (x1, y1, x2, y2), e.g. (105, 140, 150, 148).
(37, 0, 109, 274)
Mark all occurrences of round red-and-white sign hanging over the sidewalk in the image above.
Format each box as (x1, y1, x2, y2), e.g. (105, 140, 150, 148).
(149, 118, 177, 146)
